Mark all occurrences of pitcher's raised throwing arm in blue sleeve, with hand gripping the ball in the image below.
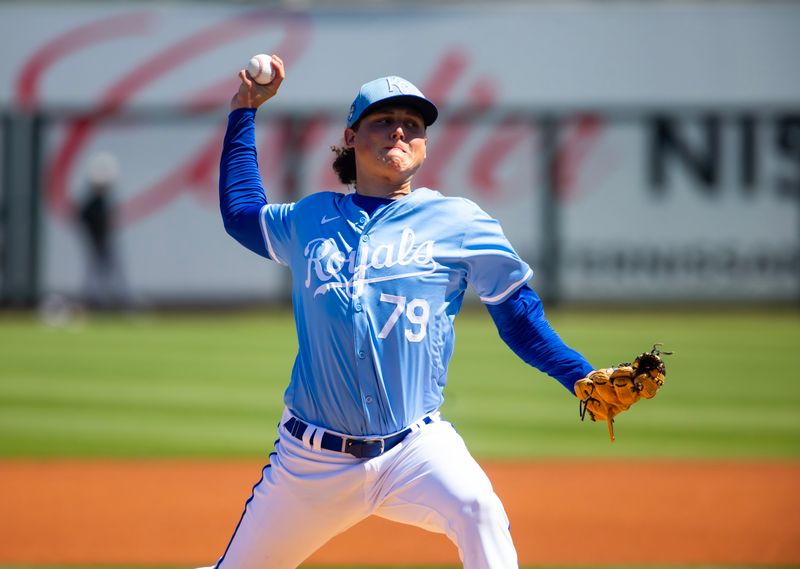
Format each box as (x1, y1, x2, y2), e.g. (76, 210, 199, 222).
(219, 55, 285, 258)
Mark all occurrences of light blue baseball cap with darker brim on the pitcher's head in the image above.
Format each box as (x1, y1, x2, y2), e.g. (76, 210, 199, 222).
(347, 75, 439, 128)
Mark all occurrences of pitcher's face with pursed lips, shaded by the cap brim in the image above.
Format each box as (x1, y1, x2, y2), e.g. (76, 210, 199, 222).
(345, 107, 427, 184)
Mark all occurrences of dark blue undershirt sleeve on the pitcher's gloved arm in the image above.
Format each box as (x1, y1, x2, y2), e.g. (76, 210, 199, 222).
(486, 285, 594, 394)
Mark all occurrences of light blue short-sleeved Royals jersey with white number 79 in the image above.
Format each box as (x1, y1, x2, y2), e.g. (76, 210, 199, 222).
(261, 188, 531, 435)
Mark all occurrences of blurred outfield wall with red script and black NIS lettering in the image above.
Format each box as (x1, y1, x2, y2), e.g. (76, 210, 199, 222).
(0, 2, 800, 302)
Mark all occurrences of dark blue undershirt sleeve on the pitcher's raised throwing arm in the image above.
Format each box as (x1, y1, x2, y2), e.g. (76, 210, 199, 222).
(219, 109, 270, 258)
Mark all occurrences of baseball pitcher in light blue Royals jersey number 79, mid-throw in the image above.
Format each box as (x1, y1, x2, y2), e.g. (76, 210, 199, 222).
(206, 56, 593, 569)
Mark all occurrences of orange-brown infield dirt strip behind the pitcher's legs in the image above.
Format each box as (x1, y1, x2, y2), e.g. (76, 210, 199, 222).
(0, 460, 800, 567)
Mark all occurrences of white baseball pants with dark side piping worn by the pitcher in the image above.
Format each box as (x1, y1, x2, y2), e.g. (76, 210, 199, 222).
(206, 412, 518, 569)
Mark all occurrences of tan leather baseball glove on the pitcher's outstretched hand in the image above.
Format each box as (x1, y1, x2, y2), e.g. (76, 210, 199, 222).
(575, 344, 672, 441)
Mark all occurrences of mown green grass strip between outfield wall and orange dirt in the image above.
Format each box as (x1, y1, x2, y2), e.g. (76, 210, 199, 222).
(0, 309, 800, 459)
